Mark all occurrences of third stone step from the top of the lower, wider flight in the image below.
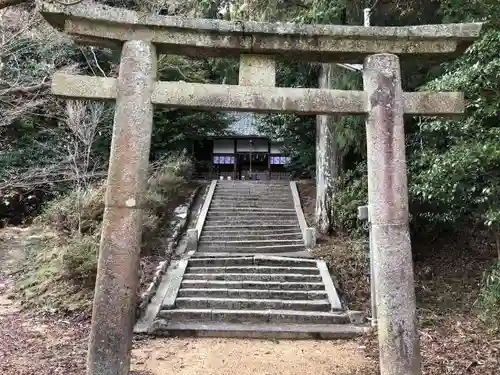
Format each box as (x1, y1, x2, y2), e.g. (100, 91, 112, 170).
(183, 273, 322, 283)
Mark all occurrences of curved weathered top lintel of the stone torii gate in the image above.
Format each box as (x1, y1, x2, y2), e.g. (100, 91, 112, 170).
(40, 3, 482, 63)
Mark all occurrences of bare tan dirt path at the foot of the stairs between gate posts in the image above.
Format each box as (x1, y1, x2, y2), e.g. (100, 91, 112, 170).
(133, 339, 376, 375)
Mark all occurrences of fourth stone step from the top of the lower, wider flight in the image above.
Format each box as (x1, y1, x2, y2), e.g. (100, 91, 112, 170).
(181, 279, 325, 291)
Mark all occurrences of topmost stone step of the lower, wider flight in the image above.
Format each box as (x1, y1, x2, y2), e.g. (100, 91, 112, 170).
(188, 255, 316, 267)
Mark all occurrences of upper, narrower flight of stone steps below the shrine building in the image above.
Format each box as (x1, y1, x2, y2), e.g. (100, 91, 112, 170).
(197, 181, 307, 256)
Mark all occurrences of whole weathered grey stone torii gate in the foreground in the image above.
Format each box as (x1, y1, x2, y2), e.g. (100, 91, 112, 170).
(41, 4, 481, 375)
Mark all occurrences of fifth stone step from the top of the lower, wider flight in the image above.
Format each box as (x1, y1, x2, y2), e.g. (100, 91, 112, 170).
(177, 288, 328, 300)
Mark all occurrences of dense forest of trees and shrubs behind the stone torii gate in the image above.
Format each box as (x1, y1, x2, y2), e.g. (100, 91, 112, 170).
(0, 0, 500, 373)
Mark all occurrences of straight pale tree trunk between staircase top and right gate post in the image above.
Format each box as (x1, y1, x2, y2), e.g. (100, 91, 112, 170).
(315, 64, 339, 234)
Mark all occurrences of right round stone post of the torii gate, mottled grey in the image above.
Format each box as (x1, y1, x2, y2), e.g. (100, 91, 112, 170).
(363, 54, 422, 375)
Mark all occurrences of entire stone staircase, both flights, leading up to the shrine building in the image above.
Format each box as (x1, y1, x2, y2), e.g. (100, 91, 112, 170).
(136, 181, 366, 339)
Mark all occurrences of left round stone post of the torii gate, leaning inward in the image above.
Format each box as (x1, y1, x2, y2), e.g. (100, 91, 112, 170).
(87, 40, 156, 375)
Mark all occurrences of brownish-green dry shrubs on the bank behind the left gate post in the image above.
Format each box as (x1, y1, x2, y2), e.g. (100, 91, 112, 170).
(11, 156, 194, 314)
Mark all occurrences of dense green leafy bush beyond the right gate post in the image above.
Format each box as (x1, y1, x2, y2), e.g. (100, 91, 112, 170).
(410, 27, 500, 227)
